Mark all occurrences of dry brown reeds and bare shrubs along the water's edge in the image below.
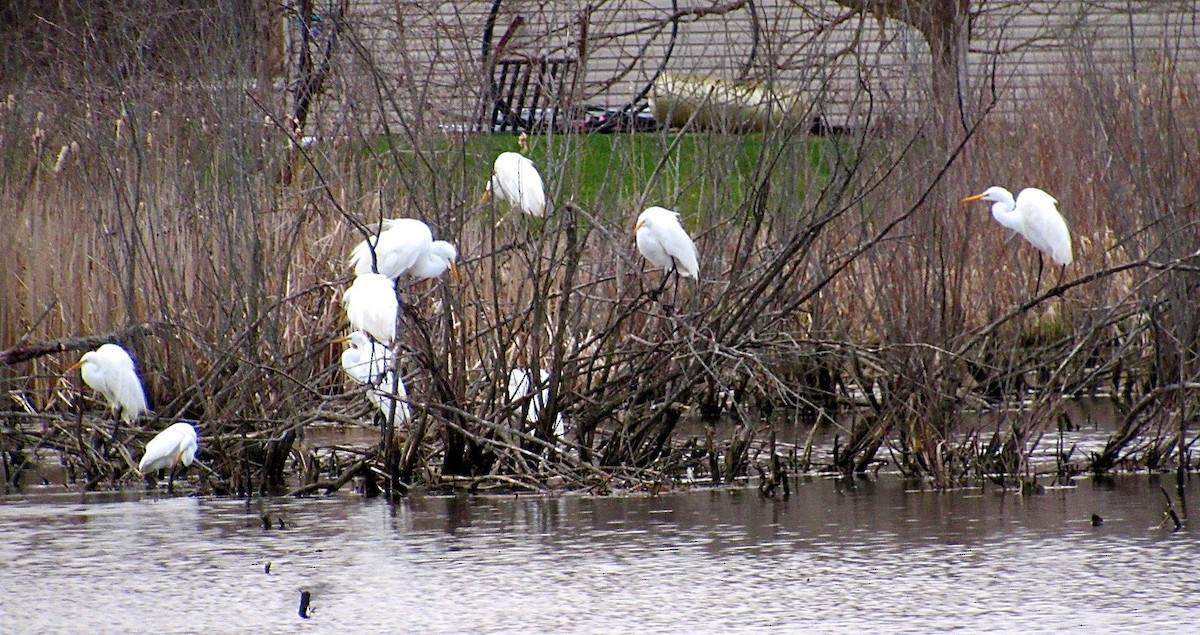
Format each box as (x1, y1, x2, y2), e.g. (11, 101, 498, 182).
(0, 58, 1200, 491)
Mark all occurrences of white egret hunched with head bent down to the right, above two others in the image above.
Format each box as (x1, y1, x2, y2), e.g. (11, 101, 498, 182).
(350, 218, 458, 280)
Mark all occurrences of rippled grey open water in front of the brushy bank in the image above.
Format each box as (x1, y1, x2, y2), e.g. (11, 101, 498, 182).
(0, 477, 1200, 634)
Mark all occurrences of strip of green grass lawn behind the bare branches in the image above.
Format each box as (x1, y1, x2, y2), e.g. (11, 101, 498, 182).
(368, 132, 838, 224)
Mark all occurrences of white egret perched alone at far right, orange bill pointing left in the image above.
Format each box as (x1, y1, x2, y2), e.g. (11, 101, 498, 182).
(962, 186, 1075, 265)
